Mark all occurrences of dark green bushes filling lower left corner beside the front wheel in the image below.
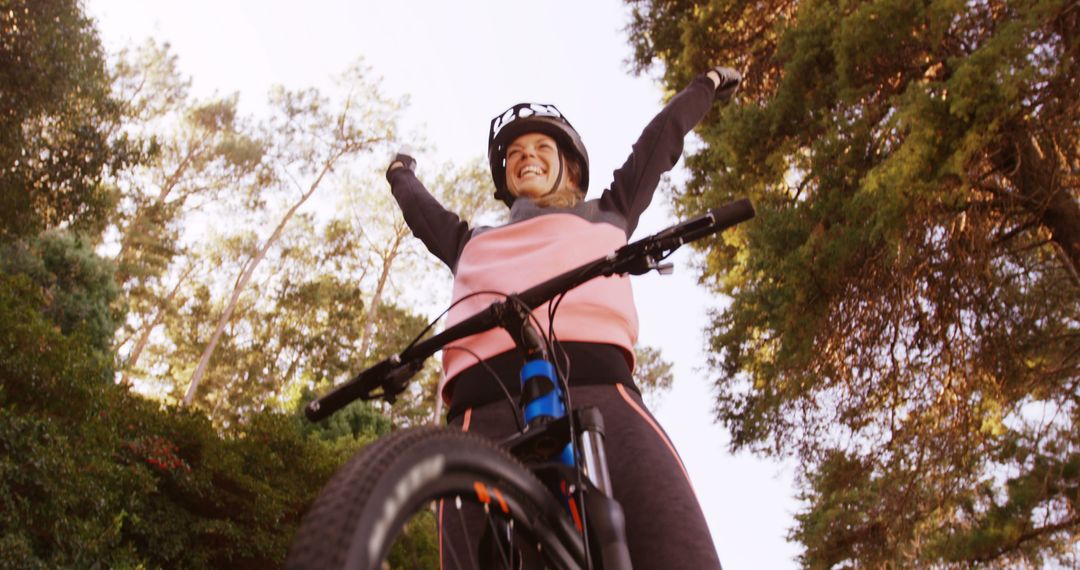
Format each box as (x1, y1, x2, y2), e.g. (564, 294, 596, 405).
(0, 270, 367, 568)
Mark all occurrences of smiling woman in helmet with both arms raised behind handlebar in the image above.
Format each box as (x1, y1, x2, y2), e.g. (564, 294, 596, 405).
(387, 67, 741, 569)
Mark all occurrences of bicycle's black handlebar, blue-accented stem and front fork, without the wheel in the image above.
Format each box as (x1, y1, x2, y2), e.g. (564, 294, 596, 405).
(305, 200, 754, 569)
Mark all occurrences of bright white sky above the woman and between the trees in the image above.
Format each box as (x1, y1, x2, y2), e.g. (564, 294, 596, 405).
(86, 0, 798, 570)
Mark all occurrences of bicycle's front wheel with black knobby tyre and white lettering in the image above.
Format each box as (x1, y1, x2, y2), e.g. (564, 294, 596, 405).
(286, 428, 584, 570)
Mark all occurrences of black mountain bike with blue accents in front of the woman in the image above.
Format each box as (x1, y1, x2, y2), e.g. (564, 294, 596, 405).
(286, 200, 754, 569)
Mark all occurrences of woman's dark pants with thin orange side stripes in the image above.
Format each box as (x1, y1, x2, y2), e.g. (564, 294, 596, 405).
(440, 384, 720, 570)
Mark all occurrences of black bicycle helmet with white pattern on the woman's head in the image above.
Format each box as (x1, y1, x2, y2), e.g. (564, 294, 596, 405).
(487, 103, 589, 206)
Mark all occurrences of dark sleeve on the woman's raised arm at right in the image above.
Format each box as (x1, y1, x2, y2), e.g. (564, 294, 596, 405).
(600, 76, 715, 238)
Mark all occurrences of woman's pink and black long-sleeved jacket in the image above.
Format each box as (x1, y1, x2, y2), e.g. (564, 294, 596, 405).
(389, 76, 714, 418)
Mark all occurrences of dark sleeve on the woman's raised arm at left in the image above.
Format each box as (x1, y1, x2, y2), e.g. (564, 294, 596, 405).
(389, 168, 470, 271)
